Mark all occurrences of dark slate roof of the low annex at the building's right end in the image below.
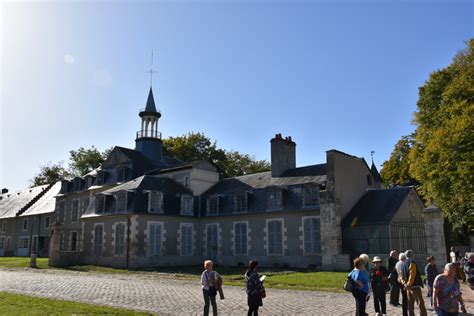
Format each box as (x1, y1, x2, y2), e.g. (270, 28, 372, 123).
(342, 187, 413, 227)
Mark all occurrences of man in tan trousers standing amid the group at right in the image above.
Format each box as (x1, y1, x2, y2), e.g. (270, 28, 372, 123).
(402, 250, 427, 316)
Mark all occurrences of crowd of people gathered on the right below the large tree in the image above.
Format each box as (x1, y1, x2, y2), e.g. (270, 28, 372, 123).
(348, 250, 474, 316)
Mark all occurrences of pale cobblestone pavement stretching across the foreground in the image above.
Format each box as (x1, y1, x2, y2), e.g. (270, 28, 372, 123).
(0, 269, 474, 315)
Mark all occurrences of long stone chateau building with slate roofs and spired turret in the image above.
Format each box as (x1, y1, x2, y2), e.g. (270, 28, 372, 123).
(0, 88, 444, 270)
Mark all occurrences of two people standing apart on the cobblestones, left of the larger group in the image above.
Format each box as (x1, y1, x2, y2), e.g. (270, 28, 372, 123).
(201, 260, 266, 316)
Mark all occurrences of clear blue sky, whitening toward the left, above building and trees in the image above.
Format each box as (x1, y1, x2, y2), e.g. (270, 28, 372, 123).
(0, 0, 474, 190)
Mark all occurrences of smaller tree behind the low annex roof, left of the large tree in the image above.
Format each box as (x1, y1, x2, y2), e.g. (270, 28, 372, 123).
(380, 135, 419, 188)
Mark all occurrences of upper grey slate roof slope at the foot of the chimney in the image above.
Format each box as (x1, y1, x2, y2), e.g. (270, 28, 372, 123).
(206, 164, 327, 194)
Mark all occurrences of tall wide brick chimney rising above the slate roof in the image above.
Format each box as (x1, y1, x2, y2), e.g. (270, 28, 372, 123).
(270, 134, 296, 177)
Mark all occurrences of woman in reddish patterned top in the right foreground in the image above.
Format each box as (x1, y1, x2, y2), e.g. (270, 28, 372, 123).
(433, 263, 467, 316)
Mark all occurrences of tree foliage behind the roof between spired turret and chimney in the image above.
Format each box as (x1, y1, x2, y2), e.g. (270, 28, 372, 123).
(163, 133, 270, 177)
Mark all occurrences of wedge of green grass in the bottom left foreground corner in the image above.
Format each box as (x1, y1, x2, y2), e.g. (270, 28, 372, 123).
(0, 292, 152, 315)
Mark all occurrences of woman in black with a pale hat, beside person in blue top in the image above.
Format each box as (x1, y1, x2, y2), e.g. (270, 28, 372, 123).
(369, 256, 388, 315)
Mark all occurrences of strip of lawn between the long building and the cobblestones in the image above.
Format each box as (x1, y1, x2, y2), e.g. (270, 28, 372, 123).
(0, 257, 347, 292)
